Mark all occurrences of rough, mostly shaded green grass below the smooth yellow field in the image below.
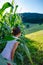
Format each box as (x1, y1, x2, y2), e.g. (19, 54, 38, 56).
(25, 38, 43, 65)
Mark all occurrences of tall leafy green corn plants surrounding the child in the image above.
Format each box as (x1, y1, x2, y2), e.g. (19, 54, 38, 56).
(0, 0, 33, 65)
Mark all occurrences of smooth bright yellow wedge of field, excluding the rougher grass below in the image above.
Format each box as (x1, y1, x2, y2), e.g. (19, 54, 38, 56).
(25, 30, 43, 43)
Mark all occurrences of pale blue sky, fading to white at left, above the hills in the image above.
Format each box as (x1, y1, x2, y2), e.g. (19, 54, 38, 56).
(0, 0, 43, 14)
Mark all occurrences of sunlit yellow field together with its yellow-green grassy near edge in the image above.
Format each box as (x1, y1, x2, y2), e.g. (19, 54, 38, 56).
(25, 30, 43, 51)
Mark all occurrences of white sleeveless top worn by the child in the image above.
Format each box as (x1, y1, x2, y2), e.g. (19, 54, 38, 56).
(1, 36, 17, 60)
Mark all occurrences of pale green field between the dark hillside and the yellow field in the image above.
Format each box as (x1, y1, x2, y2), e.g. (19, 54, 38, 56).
(25, 23, 43, 34)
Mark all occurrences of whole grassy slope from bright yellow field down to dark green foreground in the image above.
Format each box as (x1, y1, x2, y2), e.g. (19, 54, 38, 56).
(25, 30, 43, 65)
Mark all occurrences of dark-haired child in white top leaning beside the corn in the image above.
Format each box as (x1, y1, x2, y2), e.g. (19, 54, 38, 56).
(1, 27, 21, 60)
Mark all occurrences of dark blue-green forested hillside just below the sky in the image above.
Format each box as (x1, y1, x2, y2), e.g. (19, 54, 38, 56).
(20, 13, 43, 24)
